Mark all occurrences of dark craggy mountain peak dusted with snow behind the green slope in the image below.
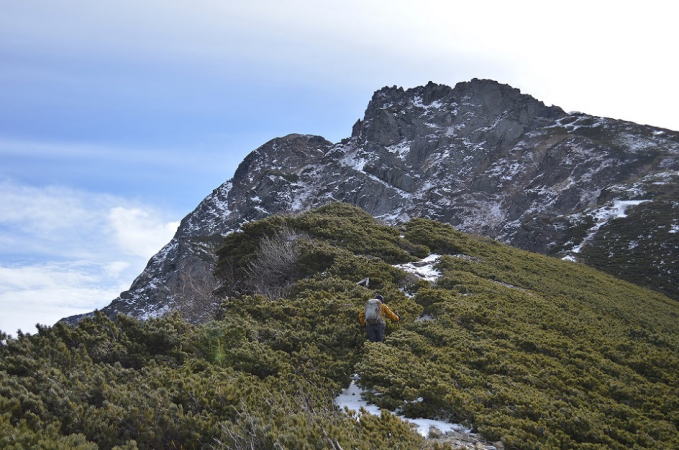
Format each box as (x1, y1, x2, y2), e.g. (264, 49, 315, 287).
(63, 79, 679, 321)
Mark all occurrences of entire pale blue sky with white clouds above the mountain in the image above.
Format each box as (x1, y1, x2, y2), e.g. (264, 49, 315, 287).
(0, 0, 679, 333)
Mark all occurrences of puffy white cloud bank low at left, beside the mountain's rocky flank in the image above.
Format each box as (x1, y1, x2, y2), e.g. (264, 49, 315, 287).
(0, 181, 178, 332)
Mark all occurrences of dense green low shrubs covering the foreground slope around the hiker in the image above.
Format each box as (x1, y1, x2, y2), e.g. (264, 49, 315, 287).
(0, 204, 679, 449)
